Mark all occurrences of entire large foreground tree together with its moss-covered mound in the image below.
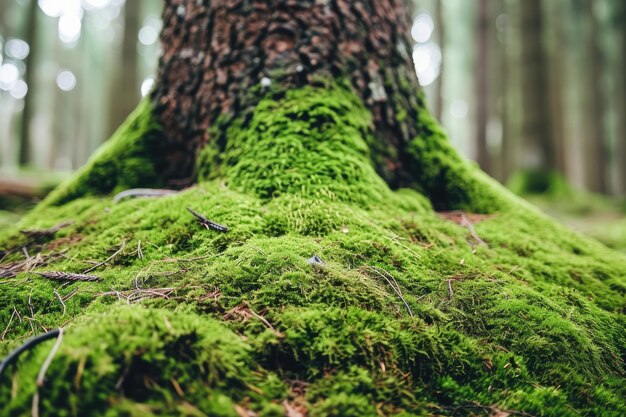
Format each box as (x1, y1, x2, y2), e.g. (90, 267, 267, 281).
(0, 0, 626, 417)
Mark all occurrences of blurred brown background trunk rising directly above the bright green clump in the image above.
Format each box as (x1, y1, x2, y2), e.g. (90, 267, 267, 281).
(520, 0, 555, 171)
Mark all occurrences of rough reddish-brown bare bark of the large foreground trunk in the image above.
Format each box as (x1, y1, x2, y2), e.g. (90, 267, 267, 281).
(152, 0, 419, 186)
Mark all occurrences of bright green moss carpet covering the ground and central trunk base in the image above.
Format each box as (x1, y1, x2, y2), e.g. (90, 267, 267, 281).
(0, 88, 626, 416)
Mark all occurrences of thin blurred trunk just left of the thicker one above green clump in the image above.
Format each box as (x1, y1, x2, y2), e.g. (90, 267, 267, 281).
(475, 0, 491, 173)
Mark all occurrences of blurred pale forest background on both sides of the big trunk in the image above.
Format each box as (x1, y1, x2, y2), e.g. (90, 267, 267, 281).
(0, 0, 626, 249)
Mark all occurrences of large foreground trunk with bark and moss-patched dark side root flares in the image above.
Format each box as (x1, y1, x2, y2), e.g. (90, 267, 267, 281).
(47, 0, 489, 210)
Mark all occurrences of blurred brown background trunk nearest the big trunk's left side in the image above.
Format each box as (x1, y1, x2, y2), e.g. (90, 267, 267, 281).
(109, 0, 141, 134)
